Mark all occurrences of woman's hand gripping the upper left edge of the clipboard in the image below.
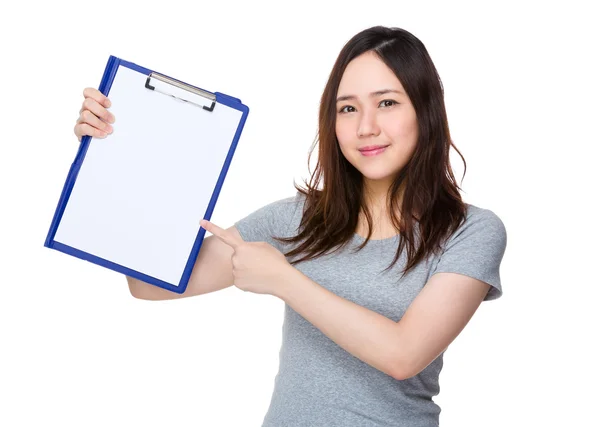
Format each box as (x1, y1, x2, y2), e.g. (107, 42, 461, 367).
(74, 87, 115, 142)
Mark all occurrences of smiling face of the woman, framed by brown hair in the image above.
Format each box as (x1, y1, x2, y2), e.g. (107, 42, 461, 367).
(335, 52, 418, 189)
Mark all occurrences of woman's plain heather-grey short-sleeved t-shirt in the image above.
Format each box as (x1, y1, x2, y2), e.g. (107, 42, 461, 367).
(235, 192, 506, 427)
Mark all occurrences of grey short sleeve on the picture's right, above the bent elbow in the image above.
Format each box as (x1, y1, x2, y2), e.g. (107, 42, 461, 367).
(431, 205, 506, 301)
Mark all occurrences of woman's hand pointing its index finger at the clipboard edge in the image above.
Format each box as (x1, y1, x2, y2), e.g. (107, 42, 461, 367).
(200, 219, 294, 295)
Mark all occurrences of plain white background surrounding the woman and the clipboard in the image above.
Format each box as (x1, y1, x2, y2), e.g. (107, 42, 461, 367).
(0, 0, 600, 427)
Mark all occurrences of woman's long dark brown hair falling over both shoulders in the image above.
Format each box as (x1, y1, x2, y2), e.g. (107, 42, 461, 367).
(274, 26, 467, 275)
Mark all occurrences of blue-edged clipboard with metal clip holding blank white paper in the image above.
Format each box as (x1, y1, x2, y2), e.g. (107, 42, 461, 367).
(44, 55, 249, 294)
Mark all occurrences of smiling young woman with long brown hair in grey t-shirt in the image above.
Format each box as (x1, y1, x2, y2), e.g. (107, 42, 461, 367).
(75, 27, 506, 427)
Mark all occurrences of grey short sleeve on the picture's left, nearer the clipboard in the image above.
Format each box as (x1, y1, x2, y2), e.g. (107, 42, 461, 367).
(234, 196, 299, 252)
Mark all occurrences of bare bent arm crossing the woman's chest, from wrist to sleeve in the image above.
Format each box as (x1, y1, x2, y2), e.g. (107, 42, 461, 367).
(275, 269, 490, 380)
